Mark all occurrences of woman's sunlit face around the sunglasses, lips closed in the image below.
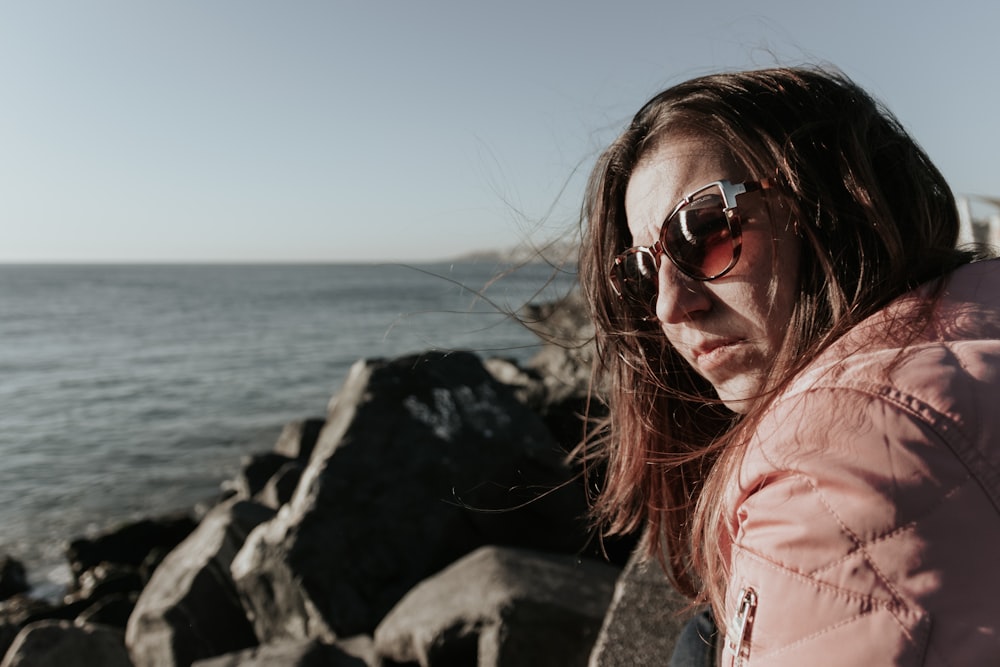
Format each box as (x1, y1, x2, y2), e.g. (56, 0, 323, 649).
(625, 136, 799, 412)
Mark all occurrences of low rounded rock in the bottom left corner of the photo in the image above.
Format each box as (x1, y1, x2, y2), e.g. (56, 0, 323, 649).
(0, 620, 132, 667)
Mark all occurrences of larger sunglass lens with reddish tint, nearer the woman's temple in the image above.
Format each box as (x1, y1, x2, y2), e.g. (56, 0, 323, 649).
(663, 195, 735, 279)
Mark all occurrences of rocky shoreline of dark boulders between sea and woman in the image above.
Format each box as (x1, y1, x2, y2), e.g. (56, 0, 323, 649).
(0, 294, 685, 667)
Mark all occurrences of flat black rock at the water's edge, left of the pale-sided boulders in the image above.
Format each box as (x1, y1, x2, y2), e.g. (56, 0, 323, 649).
(66, 512, 197, 581)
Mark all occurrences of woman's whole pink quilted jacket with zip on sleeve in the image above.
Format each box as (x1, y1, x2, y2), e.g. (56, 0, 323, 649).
(722, 261, 1000, 667)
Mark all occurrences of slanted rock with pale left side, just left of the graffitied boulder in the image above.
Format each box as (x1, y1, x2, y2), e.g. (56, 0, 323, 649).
(125, 501, 274, 667)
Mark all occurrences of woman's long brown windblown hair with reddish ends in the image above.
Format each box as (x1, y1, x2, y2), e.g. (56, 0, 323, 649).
(580, 68, 970, 605)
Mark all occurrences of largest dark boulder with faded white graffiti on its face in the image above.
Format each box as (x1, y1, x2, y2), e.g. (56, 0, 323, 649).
(233, 352, 586, 642)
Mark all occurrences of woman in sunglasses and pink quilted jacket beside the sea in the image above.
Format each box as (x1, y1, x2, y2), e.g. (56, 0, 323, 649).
(580, 68, 1000, 665)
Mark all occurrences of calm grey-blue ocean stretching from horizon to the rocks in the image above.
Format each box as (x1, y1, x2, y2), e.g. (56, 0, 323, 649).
(0, 262, 574, 596)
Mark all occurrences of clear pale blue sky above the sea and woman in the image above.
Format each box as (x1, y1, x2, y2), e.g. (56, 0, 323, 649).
(0, 0, 1000, 262)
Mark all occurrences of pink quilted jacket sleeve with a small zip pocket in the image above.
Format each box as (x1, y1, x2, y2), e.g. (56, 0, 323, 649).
(723, 389, 968, 666)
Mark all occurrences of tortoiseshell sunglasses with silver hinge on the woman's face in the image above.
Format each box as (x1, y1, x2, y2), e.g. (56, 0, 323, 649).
(610, 179, 771, 311)
